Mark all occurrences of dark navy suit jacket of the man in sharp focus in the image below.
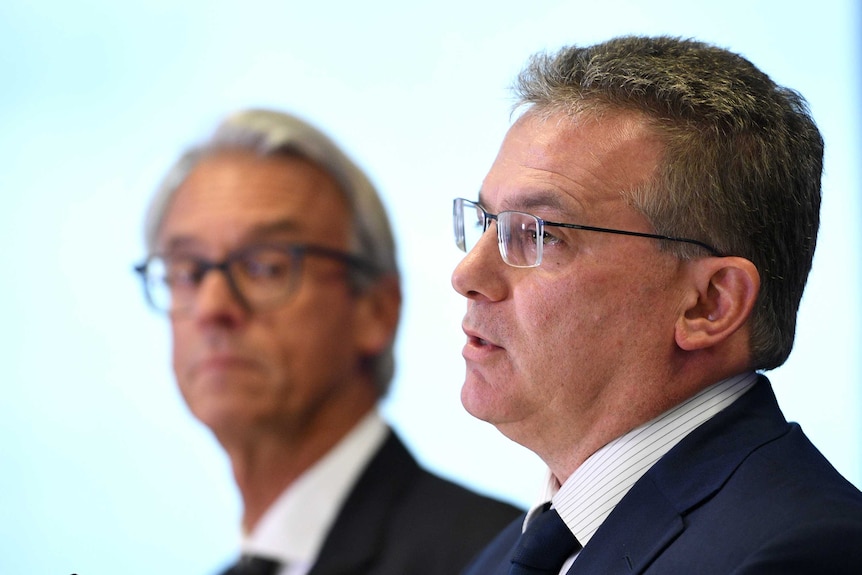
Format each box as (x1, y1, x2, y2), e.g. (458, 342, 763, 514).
(464, 376, 862, 575)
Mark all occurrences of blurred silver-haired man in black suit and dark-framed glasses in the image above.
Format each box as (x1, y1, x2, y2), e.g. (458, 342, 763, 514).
(137, 110, 519, 575)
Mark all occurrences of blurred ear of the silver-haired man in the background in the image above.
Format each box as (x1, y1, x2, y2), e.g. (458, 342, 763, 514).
(354, 276, 401, 355)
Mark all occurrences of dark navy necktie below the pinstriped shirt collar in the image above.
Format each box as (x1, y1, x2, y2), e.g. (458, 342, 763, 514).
(509, 504, 581, 575)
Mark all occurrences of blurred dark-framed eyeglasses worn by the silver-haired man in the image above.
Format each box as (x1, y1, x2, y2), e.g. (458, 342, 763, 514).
(134, 244, 377, 313)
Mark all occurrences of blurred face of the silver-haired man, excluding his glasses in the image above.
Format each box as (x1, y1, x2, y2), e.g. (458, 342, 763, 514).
(158, 153, 379, 441)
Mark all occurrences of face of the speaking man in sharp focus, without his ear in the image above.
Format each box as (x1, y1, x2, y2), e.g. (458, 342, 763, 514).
(452, 114, 696, 467)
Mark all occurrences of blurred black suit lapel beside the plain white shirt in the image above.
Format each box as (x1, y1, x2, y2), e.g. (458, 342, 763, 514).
(309, 432, 420, 575)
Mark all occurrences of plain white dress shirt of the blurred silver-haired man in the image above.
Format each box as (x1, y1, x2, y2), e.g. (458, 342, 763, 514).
(241, 410, 389, 575)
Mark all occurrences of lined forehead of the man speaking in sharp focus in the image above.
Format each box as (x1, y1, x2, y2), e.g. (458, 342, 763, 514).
(481, 112, 664, 216)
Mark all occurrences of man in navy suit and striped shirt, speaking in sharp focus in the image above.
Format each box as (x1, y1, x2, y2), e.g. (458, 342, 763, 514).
(452, 37, 862, 575)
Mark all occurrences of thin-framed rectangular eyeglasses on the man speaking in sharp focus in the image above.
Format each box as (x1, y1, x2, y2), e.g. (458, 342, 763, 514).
(452, 198, 721, 268)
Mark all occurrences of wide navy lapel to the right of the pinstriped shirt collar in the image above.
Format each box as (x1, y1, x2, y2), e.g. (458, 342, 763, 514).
(569, 376, 787, 575)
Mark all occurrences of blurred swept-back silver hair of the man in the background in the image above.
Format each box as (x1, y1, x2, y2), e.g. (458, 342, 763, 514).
(144, 109, 400, 397)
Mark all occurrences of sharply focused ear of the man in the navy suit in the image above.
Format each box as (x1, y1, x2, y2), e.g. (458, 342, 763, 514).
(675, 257, 760, 351)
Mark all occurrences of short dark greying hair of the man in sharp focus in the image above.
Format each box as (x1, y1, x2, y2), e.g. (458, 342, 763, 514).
(515, 36, 823, 369)
